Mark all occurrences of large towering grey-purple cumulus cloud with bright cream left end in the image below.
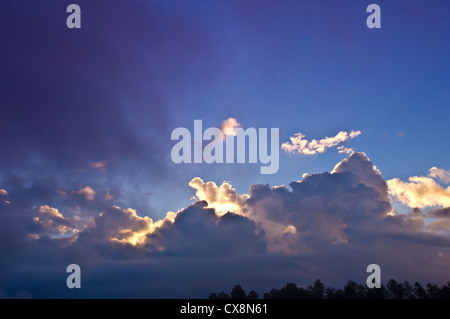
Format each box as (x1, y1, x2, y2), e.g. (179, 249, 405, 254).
(189, 153, 391, 254)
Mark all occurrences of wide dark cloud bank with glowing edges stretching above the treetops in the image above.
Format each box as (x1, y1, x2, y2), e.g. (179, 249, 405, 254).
(0, 153, 450, 298)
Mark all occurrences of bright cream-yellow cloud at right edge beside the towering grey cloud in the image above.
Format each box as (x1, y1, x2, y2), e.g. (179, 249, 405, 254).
(387, 176, 450, 208)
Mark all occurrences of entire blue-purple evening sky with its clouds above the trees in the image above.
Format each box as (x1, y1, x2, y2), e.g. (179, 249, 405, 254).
(0, 0, 450, 298)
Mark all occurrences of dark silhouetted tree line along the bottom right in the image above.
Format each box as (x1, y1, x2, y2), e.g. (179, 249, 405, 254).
(209, 279, 450, 299)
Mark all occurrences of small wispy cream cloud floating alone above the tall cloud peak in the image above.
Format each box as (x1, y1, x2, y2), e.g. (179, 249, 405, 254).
(281, 131, 361, 155)
